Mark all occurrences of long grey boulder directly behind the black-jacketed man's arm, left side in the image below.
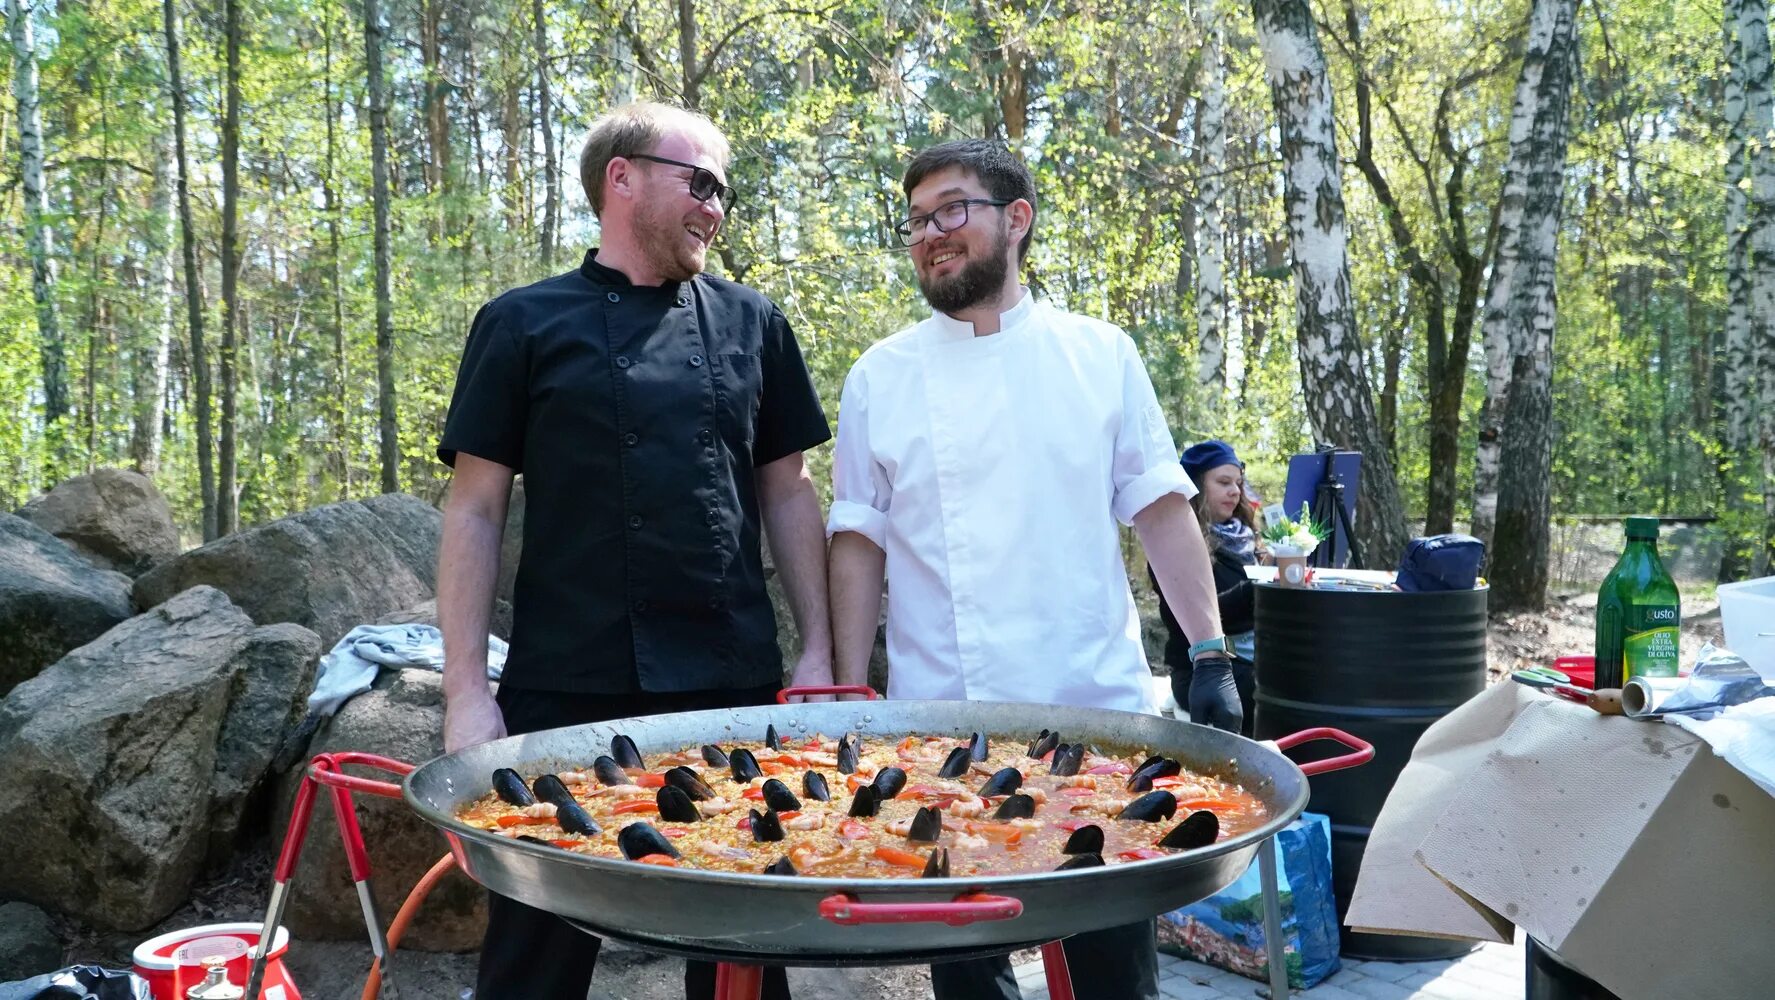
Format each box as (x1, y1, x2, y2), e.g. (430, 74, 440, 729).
(135, 497, 440, 648)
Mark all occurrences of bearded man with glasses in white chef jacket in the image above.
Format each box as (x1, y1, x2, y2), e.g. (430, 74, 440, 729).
(827, 140, 1237, 1000)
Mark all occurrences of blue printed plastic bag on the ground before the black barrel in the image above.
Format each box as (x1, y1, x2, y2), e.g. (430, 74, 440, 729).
(1159, 812, 1342, 989)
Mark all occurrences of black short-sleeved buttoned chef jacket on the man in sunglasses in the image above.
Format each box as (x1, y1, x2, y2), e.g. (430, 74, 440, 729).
(438, 250, 831, 693)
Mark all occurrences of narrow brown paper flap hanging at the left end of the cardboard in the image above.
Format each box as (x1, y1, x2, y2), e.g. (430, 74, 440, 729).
(1344, 684, 1535, 943)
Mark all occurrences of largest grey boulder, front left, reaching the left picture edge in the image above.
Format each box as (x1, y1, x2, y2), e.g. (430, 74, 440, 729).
(0, 588, 320, 931)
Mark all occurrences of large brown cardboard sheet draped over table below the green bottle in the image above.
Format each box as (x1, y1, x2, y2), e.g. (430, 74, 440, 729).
(1420, 696, 1775, 1000)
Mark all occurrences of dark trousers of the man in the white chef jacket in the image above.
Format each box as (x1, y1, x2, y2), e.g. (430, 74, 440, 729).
(930, 920, 1159, 1000)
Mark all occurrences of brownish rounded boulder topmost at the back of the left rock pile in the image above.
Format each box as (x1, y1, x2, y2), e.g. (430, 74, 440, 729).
(18, 469, 179, 577)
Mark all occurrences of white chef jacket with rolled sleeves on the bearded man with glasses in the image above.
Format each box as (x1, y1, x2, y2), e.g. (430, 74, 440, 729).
(827, 293, 1195, 712)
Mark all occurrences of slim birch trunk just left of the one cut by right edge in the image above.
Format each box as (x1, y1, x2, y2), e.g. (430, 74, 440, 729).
(1720, 0, 1761, 583)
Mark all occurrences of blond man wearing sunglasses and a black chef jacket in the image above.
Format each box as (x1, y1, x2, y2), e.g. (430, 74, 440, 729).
(438, 103, 832, 1000)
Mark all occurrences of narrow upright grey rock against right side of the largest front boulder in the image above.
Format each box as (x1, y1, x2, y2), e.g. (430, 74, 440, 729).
(209, 622, 321, 860)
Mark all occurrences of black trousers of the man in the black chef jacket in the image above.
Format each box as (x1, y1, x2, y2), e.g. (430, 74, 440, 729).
(474, 684, 788, 1000)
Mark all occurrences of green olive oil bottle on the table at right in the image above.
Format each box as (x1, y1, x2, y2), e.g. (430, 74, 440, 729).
(1596, 517, 1683, 689)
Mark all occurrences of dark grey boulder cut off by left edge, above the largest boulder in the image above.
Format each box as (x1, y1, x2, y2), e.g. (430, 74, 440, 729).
(0, 513, 130, 696)
